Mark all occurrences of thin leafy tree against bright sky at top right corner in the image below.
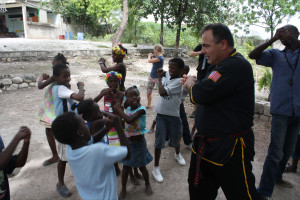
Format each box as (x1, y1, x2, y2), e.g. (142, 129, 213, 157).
(241, 0, 300, 38)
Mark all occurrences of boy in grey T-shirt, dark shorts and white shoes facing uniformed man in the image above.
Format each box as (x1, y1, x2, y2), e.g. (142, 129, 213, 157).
(152, 58, 186, 182)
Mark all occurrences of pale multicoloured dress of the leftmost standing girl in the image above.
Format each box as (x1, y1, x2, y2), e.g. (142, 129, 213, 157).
(38, 82, 56, 128)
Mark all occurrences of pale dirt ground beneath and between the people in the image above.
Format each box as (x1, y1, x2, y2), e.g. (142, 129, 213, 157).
(0, 58, 300, 200)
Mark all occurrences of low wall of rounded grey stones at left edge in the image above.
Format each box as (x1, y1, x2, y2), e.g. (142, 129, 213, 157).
(0, 74, 37, 93)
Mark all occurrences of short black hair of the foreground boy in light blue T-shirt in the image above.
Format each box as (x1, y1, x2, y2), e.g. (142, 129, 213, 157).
(51, 112, 79, 144)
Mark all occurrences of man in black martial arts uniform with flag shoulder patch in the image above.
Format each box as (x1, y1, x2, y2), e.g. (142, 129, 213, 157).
(182, 24, 260, 200)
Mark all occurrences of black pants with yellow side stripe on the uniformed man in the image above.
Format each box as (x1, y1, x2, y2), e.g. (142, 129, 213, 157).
(188, 141, 261, 200)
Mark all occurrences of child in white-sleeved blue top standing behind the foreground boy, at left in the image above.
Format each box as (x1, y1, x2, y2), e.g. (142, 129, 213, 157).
(52, 64, 84, 197)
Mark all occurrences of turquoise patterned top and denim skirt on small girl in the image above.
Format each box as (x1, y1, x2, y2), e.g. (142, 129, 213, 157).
(121, 106, 153, 167)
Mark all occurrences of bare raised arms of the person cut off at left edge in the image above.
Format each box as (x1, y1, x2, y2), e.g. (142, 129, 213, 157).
(0, 126, 31, 170)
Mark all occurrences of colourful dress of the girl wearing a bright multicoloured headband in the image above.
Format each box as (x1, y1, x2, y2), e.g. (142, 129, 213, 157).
(104, 96, 120, 146)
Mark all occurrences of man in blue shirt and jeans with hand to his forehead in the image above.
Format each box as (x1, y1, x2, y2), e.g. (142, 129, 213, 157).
(249, 25, 300, 199)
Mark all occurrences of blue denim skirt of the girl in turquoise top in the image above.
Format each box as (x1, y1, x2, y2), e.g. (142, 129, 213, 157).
(121, 136, 153, 167)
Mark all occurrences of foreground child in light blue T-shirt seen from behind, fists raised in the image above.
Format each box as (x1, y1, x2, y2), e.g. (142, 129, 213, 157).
(52, 112, 130, 200)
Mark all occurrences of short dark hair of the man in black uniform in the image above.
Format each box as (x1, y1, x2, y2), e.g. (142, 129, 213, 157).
(201, 23, 234, 48)
